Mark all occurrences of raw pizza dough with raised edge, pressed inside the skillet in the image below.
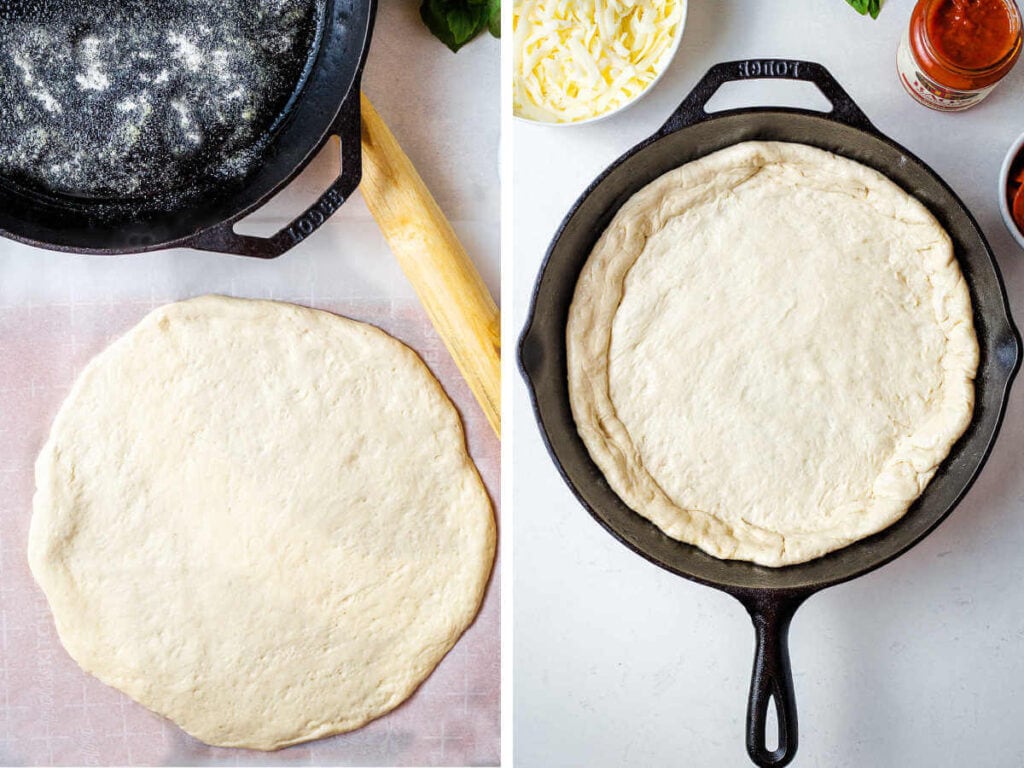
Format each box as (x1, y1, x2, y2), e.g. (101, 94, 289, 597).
(567, 142, 978, 566)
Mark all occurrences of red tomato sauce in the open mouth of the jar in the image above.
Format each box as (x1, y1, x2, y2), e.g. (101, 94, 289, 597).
(927, 0, 1016, 70)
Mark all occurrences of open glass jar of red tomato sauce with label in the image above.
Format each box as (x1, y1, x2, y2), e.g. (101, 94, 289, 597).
(896, 0, 1022, 112)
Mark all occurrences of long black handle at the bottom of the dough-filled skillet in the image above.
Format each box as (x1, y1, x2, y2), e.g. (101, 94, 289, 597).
(742, 596, 804, 768)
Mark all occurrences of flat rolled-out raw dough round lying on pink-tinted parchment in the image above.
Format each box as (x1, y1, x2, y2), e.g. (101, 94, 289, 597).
(29, 296, 495, 750)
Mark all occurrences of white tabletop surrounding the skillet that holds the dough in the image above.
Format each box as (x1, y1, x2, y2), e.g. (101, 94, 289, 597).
(513, 0, 1024, 768)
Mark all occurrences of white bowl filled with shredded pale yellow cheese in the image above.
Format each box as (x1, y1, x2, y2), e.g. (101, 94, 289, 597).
(512, 0, 687, 125)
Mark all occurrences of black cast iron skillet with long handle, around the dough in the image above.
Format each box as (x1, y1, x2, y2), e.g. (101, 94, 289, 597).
(519, 59, 1021, 766)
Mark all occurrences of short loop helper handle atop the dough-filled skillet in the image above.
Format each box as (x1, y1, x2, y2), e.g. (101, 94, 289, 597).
(658, 58, 877, 136)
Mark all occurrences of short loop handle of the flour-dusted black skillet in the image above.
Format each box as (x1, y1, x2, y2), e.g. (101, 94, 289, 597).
(182, 79, 362, 259)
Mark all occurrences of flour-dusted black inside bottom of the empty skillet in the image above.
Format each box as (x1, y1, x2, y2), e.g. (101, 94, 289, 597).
(0, 0, 324, 199)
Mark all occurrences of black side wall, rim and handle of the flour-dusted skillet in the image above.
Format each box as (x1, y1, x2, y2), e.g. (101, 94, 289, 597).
(0, 0, 377, 258)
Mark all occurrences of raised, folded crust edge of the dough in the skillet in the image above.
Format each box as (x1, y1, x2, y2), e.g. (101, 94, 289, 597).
(565, 141, 979, 567)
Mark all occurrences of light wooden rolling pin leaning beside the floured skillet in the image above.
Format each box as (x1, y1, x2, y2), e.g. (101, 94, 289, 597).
(359, 94, 501, 439)
